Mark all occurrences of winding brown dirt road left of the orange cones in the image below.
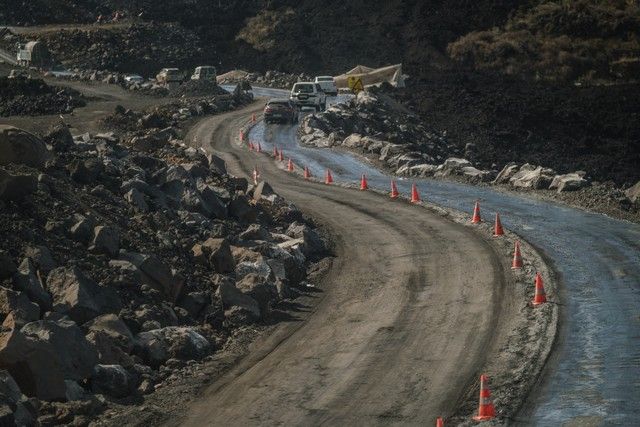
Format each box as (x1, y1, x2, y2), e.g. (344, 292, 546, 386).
(182, 105, 511, 426)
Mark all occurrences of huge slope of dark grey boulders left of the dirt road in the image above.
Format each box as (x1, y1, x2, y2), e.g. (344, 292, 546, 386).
(0, 117, 326, 425)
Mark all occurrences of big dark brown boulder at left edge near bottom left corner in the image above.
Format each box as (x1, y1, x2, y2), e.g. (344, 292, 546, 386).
(0, 318, 66, 400)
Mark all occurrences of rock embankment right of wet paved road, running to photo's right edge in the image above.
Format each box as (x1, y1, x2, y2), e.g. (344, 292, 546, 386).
(299, 89, 640, 219)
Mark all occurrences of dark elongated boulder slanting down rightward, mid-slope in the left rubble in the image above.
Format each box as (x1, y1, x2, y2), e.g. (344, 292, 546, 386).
(122, 252, 185, 302)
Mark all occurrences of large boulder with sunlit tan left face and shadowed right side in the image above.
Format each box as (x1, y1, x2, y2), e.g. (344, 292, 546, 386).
(47, 267, 121, 324)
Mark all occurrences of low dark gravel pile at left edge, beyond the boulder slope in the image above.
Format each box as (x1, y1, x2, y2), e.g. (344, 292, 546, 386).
(0, 77, 86, 117)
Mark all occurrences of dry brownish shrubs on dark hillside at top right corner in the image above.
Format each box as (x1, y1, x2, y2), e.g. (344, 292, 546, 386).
(448, 0, 640, 81)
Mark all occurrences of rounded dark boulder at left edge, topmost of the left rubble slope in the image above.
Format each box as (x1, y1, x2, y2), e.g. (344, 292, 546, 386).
(0, 125, 50, 168)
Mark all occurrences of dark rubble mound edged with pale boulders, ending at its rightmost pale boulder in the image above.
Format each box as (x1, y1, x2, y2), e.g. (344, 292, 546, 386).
(299, 91, 600, 192)
